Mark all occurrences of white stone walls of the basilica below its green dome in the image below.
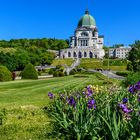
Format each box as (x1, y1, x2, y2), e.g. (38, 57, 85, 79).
(60, 23, 105, 58)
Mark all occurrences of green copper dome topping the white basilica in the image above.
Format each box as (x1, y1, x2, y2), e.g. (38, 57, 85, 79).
(78, 11, 96, 27)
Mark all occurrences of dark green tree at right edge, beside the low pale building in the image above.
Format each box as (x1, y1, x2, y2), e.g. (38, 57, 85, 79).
(128, 41, 140, 72)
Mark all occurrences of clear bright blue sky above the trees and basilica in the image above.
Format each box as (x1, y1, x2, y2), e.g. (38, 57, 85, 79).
(0, 0, 140, 45)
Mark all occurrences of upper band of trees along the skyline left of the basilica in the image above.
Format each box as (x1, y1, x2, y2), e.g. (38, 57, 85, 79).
(0, 38, 69, 50)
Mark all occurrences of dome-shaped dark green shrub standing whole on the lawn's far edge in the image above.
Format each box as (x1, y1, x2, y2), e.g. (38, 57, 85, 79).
(21, 64, 38, 79)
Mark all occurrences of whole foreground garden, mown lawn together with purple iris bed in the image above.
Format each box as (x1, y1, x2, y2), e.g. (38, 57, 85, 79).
(0, 69, 140, 140)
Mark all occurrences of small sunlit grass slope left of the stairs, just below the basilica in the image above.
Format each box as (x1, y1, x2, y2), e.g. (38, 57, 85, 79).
(52, 58, 74, 66)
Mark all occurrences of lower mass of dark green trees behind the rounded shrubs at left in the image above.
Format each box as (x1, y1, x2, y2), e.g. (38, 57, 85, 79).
(0, 48, 55, 71)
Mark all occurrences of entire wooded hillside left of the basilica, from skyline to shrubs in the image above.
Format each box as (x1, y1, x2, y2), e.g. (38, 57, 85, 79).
(0, 38, 68, 71)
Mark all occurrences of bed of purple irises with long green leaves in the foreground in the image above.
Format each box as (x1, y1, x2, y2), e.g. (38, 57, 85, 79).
(46, 82, 140, 140)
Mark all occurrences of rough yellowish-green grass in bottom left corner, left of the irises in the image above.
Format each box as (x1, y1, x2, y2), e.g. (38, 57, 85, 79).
(0, 105, 51, 140)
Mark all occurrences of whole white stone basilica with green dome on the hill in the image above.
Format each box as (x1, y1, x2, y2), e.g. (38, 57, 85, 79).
(60, 10, 105, 59)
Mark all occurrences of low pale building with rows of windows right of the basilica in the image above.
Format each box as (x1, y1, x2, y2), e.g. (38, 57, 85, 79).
(109, 47, 131, 59)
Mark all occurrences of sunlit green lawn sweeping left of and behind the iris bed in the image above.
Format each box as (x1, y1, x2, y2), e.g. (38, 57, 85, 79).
(0, 73, 118, 140)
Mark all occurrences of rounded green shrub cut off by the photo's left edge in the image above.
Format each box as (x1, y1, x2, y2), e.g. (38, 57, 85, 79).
(0, 66, 12, 82)
